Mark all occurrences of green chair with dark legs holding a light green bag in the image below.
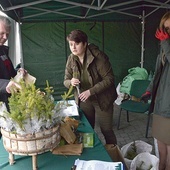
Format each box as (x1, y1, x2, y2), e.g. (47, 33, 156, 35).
(117, 80, 151, 138)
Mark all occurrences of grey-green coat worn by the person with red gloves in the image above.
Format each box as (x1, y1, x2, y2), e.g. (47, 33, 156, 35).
(147, 39, 170, 117)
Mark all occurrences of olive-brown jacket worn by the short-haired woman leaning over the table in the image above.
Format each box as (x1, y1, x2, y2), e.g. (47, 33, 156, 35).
(64, 44, 117, 110)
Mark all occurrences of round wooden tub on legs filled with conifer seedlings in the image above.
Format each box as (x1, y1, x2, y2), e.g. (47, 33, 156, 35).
(0, 72, 61, 169)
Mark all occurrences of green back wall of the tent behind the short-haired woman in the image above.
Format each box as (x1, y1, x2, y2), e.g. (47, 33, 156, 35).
(21, 18, 156, 99)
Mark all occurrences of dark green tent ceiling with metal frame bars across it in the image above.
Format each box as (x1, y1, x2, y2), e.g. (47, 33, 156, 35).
(0, 0, 170, 22)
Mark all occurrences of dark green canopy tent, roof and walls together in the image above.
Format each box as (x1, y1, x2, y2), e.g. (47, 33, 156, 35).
(0, 0, 165, 98)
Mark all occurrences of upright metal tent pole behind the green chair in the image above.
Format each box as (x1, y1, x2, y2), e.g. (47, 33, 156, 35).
(140, 10, 145, 68)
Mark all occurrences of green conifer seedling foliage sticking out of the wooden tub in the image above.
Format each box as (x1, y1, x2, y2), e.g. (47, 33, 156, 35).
(9, 80, 55, 130)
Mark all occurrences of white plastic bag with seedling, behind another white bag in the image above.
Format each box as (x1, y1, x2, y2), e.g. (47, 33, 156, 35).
(121, 140, 152, 168)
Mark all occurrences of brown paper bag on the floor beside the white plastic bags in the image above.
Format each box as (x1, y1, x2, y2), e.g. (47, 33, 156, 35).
(105, 144, 128, 170)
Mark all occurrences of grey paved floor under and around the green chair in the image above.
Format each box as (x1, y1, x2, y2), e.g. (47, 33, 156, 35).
(95, 104, 154, 154)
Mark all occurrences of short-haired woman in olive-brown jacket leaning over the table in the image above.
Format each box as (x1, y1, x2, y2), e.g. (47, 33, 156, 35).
(64, 30, 117, 144)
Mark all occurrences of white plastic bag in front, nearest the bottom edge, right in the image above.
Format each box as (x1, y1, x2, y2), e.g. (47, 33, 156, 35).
(130, 152, 159, 170)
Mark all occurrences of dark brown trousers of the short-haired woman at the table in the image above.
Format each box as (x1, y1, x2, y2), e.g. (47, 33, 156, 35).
(80, 99, 117, 144)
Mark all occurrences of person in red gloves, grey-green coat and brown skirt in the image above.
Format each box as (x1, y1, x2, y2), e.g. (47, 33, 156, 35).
(142, 12, 170, 170)
